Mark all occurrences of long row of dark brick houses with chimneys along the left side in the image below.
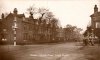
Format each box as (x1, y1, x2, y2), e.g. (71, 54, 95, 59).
(0, 8, 58, 44)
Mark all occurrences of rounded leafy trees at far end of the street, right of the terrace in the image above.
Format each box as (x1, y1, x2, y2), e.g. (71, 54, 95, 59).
(64, 24, 83, 41)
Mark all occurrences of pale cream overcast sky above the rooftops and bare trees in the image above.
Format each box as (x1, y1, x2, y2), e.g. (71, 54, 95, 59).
(0, 0, 100, 30)
